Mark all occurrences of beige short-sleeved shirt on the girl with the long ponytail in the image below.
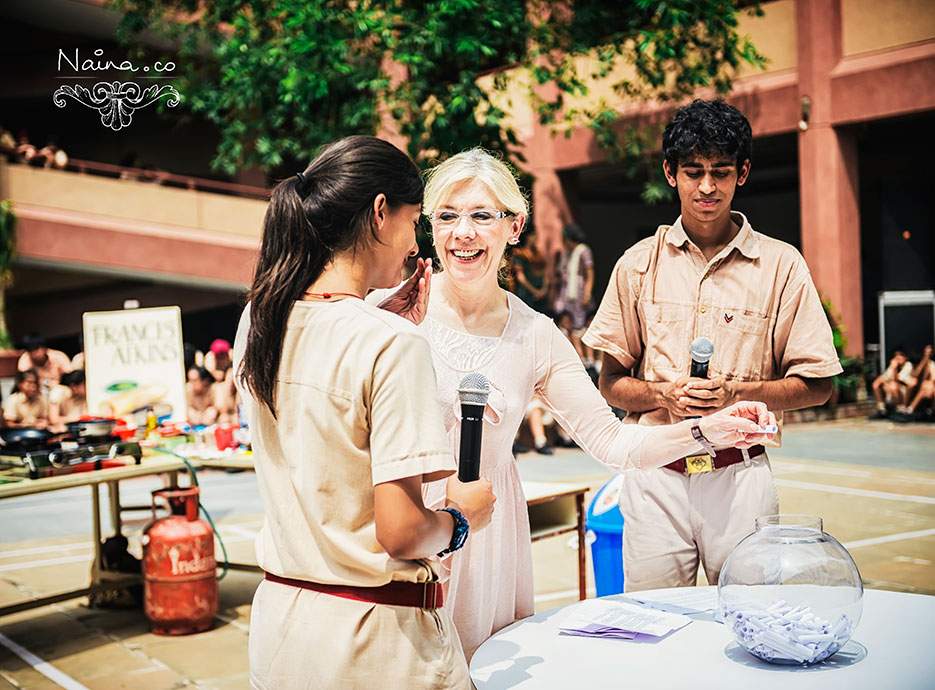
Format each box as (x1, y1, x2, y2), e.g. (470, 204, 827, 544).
(234, 299, 456, 587)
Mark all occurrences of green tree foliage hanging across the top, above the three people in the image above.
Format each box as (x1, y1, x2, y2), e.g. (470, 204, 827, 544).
(112, 0, 764, 187)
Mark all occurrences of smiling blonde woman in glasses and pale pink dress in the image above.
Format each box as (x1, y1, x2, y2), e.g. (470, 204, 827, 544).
(406, 149, 773, 660)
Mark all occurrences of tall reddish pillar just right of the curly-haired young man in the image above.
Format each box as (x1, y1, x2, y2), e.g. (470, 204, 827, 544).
(796, 0, 864, 354)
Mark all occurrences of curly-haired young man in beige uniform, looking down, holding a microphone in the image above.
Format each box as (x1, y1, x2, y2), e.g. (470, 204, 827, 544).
(583, 100, 841, 591)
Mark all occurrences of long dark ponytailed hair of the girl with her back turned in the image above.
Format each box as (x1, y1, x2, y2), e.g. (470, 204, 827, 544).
(238, 136, 422, 417)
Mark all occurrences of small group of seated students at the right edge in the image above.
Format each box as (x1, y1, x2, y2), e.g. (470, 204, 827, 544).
(870, 345, 935, 423)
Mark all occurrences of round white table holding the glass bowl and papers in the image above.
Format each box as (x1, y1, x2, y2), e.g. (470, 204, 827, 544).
(471, 590, 935, 690)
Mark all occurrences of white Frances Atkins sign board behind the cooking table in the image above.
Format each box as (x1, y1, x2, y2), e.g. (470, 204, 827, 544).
(84, 307, 188, 421)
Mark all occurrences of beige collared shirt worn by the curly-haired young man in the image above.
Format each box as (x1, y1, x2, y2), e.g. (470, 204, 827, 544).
(583, 212, 842, 444)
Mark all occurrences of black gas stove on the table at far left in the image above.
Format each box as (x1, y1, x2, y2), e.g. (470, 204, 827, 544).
(0, 436, 143, 479)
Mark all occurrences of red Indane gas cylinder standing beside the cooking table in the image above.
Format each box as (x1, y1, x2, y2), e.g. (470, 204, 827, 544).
(142, 486, 218, 635)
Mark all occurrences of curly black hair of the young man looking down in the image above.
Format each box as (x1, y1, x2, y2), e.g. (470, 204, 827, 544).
(662, 99, 753, 174)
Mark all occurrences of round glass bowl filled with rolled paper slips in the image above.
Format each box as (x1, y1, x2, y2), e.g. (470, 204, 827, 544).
(718, 515, 864, 664)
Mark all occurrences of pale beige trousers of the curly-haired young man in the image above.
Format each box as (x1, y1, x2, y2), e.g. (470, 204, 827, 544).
(620, 453, 779, 592)
